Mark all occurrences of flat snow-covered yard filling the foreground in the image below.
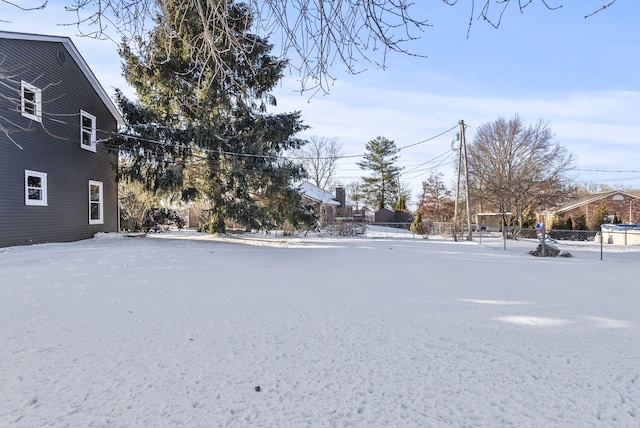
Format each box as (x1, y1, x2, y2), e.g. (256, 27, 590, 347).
(0, 232, 640, 428)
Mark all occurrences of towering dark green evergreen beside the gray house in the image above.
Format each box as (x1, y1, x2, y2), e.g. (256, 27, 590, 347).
(112, 1, 312, 232)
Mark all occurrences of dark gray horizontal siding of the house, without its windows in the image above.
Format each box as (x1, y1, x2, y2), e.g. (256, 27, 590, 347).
(0, 38, 118, 247)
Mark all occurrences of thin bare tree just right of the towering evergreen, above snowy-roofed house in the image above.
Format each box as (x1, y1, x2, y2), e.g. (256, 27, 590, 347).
(298, 135, 342, 190)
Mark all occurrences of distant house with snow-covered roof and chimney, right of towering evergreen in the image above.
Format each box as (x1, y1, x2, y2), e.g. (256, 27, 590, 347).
(298, 181, 354, 224)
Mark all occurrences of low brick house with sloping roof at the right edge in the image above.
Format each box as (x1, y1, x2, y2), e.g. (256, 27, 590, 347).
(544, 190, 640, 225)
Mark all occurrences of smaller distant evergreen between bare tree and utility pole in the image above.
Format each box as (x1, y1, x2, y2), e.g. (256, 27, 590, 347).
(357, 137, 402, 209)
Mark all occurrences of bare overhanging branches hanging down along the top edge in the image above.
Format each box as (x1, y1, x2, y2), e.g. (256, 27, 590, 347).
(0, 0, 616, 92)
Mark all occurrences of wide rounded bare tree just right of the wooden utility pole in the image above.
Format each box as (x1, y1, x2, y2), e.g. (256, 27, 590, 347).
(468, 115, 573, 232)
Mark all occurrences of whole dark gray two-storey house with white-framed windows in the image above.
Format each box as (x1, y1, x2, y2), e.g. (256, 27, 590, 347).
(0, 32, 122, 247)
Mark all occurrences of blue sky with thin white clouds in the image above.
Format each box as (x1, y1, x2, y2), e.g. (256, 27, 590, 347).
(0, 0, 640, 202)
